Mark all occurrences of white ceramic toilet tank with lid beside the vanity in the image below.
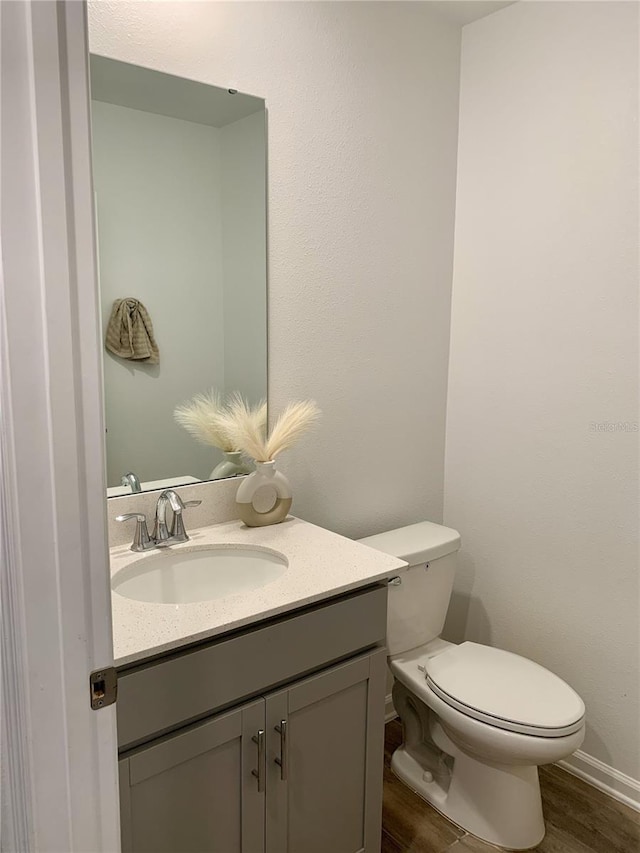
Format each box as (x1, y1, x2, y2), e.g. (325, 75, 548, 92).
(359, 521, 460, 655)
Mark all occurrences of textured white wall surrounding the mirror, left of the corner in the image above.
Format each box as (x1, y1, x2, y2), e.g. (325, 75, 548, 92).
(89, 0, 460, 535)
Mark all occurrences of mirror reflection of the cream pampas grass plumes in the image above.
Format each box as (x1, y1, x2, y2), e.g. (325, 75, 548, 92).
(173, 390, 267, 452)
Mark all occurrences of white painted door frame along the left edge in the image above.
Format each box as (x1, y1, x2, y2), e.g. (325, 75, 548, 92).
(0, 0, 120, 853)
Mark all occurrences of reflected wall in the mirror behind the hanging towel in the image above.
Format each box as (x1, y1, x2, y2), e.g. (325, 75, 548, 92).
(92, 101, 224, 486)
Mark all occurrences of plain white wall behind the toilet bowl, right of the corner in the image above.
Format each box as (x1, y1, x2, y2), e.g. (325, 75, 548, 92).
(445, 2, 640, 779)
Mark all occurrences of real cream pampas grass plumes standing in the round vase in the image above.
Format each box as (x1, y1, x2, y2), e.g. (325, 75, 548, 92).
(228, 394, 320, 462)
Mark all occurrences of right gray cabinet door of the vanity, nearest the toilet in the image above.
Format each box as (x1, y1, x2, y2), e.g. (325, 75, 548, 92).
(266, 650, 386, 853)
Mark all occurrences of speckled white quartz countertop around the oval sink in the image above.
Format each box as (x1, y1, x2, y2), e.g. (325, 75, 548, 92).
(110, 517, 406, 666)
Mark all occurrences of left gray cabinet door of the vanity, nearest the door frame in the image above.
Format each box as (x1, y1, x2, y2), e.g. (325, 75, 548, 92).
(120, 699, 265, 853)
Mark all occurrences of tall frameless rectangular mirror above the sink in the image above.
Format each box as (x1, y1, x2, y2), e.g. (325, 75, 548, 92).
(91, 55, 267, 496)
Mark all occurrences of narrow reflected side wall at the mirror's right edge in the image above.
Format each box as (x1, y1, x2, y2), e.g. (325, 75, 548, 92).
(220, 112, 267, 403)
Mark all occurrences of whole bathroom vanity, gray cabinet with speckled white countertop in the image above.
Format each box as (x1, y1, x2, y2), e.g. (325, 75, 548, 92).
(112, 519, 404, 853)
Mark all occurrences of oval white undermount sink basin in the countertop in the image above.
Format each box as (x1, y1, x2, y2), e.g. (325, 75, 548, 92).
(111, 545, 289, 604)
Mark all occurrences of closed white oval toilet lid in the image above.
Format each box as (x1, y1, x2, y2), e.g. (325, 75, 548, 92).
(425, 643, 585, 737)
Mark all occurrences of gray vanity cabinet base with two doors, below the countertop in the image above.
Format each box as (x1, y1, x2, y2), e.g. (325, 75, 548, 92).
(118, 586, 386, 853)
